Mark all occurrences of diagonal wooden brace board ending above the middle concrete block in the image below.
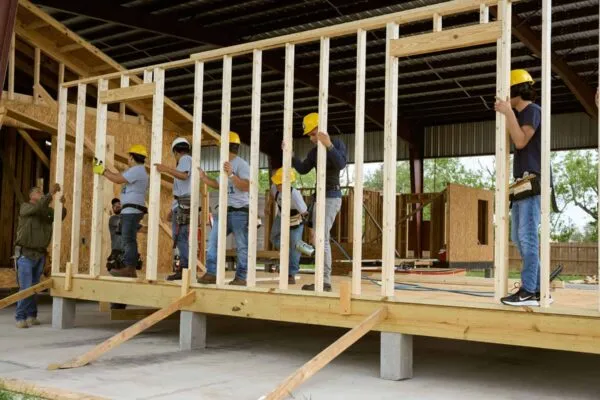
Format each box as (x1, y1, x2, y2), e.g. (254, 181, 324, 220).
(48, 292, 196, 370)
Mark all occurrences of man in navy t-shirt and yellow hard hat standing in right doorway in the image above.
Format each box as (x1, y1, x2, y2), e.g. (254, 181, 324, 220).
(495, 69, 542, 306)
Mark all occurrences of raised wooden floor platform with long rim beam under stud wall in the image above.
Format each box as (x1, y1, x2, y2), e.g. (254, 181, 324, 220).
(51, 272, 600, 354)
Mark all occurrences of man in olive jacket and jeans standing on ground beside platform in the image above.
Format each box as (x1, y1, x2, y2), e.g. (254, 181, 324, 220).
(14, 183, 67, 328)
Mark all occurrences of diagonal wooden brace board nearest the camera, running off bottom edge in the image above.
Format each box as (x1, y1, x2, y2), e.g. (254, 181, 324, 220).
(262, 306, 388, 400)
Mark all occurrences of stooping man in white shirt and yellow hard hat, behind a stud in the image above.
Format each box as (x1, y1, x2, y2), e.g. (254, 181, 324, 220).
(271, 168, 308, 285)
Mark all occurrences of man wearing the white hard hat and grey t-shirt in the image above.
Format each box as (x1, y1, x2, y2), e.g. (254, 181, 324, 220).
(155, 137, 192, 281)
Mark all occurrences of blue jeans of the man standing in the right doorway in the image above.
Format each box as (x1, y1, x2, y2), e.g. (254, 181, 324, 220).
(510, 196, 541, 293)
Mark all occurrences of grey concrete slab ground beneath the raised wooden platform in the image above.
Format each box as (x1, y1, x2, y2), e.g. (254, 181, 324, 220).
(0, 299, 600, 400)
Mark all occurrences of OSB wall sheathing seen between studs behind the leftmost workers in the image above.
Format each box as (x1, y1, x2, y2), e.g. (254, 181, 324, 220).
(50, 104, 183, 275)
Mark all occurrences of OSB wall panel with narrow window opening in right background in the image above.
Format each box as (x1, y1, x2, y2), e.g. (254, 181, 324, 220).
(447, 184, 494, 262)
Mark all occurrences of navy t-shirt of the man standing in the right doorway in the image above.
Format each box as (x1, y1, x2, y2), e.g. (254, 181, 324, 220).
(513, 103, 542, 179)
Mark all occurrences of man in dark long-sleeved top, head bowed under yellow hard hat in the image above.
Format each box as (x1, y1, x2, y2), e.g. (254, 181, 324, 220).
(284, 113, 347, 292)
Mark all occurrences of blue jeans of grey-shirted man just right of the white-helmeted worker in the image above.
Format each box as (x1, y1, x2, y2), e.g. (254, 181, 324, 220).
(206, 211, 248, 281)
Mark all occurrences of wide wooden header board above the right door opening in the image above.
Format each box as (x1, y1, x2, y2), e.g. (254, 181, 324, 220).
(390, 21, 501, 57)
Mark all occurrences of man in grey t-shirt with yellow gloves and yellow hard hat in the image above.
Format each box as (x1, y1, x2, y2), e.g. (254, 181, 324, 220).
(94, 144, 148, 278)
